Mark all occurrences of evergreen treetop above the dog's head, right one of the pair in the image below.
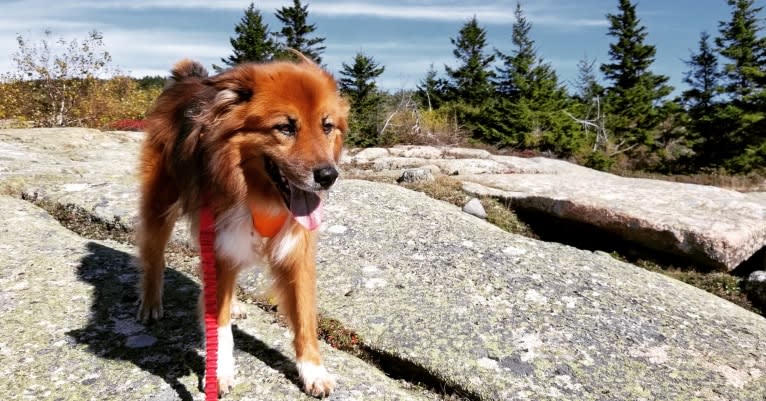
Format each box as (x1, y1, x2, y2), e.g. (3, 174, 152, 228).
(274, 0, 325, 64)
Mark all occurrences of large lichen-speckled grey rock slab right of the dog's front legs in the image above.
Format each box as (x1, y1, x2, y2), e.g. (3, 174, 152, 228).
(319, 181, 766, 400)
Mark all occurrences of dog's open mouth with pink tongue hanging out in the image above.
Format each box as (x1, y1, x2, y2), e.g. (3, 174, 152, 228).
(266, 157, 322, 230)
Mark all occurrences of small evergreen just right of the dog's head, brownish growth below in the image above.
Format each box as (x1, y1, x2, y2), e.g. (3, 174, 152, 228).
(338, 53, 385, 146)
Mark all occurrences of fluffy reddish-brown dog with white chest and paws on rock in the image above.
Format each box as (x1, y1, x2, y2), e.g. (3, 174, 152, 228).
(137, 52, 349, 397)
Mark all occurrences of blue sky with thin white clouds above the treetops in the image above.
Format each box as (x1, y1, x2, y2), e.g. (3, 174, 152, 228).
(0, 0, 752, 93)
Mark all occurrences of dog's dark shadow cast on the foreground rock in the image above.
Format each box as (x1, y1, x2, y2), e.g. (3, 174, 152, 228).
(67, 242, 299, 400)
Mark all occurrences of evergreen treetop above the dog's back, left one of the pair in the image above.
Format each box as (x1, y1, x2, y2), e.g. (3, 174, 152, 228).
(220, 3, 276, 70)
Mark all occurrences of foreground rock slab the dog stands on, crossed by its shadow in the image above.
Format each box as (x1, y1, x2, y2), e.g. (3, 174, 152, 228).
(0, 196, 436, 401)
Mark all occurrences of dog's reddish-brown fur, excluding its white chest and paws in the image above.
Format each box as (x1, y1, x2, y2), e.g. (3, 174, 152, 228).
(138, 59, 348, 394)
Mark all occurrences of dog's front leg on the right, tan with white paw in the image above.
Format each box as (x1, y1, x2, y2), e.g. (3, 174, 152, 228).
(270, 225, 335, 397)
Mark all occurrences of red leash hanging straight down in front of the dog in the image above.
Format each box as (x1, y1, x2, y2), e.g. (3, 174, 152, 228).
(199, 200, 218, 401)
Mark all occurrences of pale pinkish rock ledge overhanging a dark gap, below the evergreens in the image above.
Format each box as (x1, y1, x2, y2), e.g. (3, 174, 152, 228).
(345, 146, 766, 270)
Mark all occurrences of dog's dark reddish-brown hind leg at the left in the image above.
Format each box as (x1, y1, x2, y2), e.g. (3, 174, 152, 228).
(136, 149, 178, 322)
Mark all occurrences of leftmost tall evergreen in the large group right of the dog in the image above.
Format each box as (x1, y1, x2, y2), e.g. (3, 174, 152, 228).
(445, 16, 495, 106)
